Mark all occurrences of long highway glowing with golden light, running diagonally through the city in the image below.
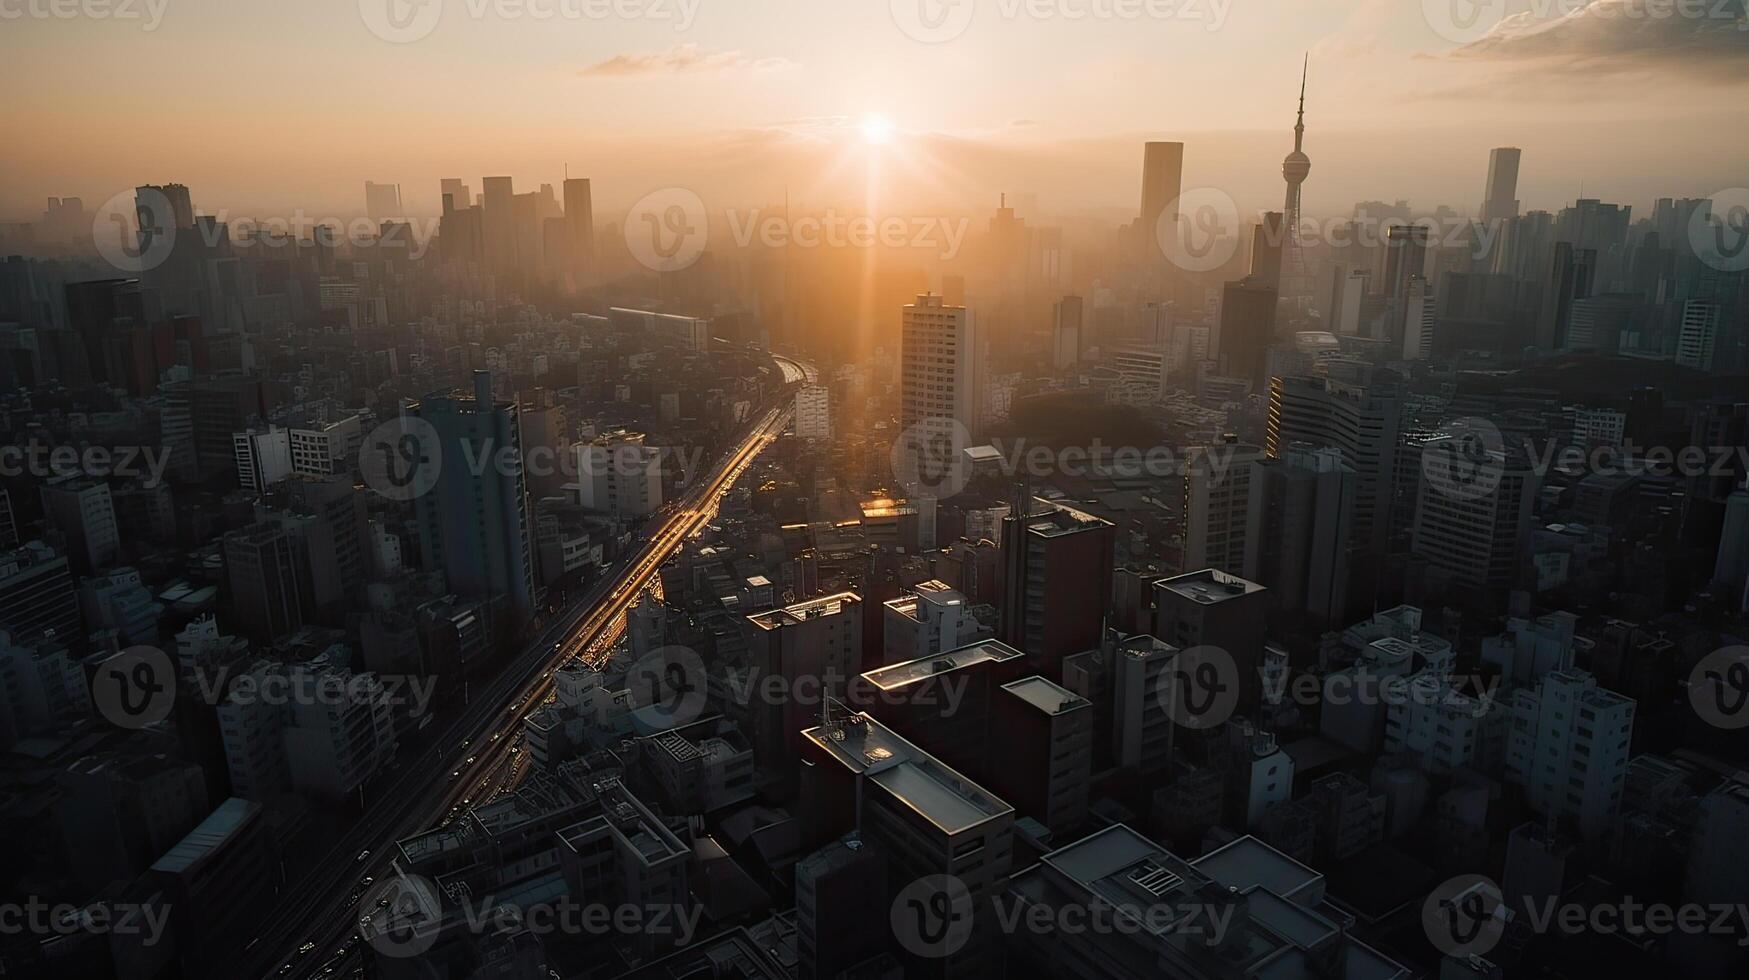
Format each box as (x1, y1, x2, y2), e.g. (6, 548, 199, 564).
(255, 369, 817, 978)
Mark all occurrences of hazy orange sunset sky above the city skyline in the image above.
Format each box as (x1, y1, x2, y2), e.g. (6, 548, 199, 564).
(0, 0, 1749, 221)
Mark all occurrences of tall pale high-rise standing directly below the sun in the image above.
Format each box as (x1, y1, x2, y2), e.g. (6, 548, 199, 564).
(899, 294, 981, 438)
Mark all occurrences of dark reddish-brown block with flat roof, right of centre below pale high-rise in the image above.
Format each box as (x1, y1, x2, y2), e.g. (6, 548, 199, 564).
(997, 497, 1116, 681)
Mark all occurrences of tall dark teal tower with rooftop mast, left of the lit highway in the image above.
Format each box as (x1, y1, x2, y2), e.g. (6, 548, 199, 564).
(411, 371, 535, 632)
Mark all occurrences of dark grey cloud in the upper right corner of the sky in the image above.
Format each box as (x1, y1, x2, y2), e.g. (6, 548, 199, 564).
(1443, 0, 1749, 81)
